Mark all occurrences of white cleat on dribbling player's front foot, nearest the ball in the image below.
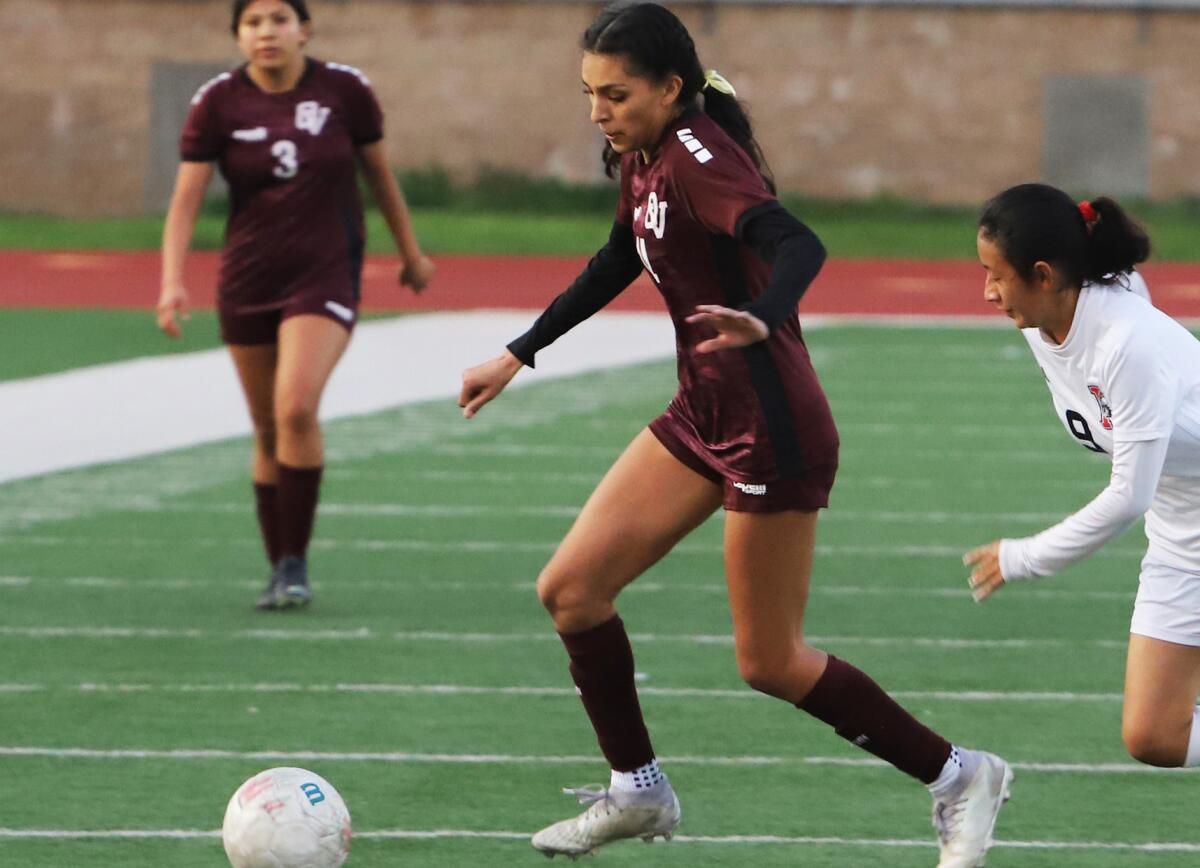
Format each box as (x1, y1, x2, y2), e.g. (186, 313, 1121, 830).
(530, 776, 683, 858)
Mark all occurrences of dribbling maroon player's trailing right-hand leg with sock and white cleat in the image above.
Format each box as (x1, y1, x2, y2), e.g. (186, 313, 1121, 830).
(725, 511, 1012, 868)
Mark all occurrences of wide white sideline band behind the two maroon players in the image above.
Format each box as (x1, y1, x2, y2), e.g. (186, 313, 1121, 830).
(0, 312, 674, 483)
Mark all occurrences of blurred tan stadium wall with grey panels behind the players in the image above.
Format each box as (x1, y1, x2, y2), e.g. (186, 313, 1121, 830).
(0, 0, 1200, 216)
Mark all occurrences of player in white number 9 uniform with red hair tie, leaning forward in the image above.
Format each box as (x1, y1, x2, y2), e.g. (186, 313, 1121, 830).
(964, 184, 1200, 766)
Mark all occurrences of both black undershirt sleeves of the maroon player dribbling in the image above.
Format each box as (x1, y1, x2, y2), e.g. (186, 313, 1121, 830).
(509, 200, 826, 367)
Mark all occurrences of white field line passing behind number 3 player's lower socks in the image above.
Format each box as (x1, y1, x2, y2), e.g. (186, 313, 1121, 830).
(0, 533, 1146, 561)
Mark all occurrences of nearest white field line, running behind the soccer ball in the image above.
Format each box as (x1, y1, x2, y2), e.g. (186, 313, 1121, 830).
(0, 828, 1200, 852)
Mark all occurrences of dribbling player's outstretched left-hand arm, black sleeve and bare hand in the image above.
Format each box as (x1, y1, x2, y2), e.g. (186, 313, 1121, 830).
(458, 221, 642, 419)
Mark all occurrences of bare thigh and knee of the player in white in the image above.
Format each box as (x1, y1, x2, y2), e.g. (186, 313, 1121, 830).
(1121, 634, 1200, 767)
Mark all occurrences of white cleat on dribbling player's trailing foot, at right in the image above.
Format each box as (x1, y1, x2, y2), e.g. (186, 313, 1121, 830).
(934, 752, 1013, 868)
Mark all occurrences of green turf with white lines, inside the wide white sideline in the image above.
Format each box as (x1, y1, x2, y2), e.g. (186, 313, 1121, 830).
(0, 328, 1200, 868)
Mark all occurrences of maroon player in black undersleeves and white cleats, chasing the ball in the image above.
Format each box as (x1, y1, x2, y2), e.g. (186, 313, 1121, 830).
(460, 2, 1012, 868)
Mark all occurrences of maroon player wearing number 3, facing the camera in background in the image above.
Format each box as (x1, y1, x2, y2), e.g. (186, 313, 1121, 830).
(157, 0, 433, 609)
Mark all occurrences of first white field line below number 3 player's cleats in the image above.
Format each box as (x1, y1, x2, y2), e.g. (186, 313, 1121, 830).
(0, 627, 1128, 651)
